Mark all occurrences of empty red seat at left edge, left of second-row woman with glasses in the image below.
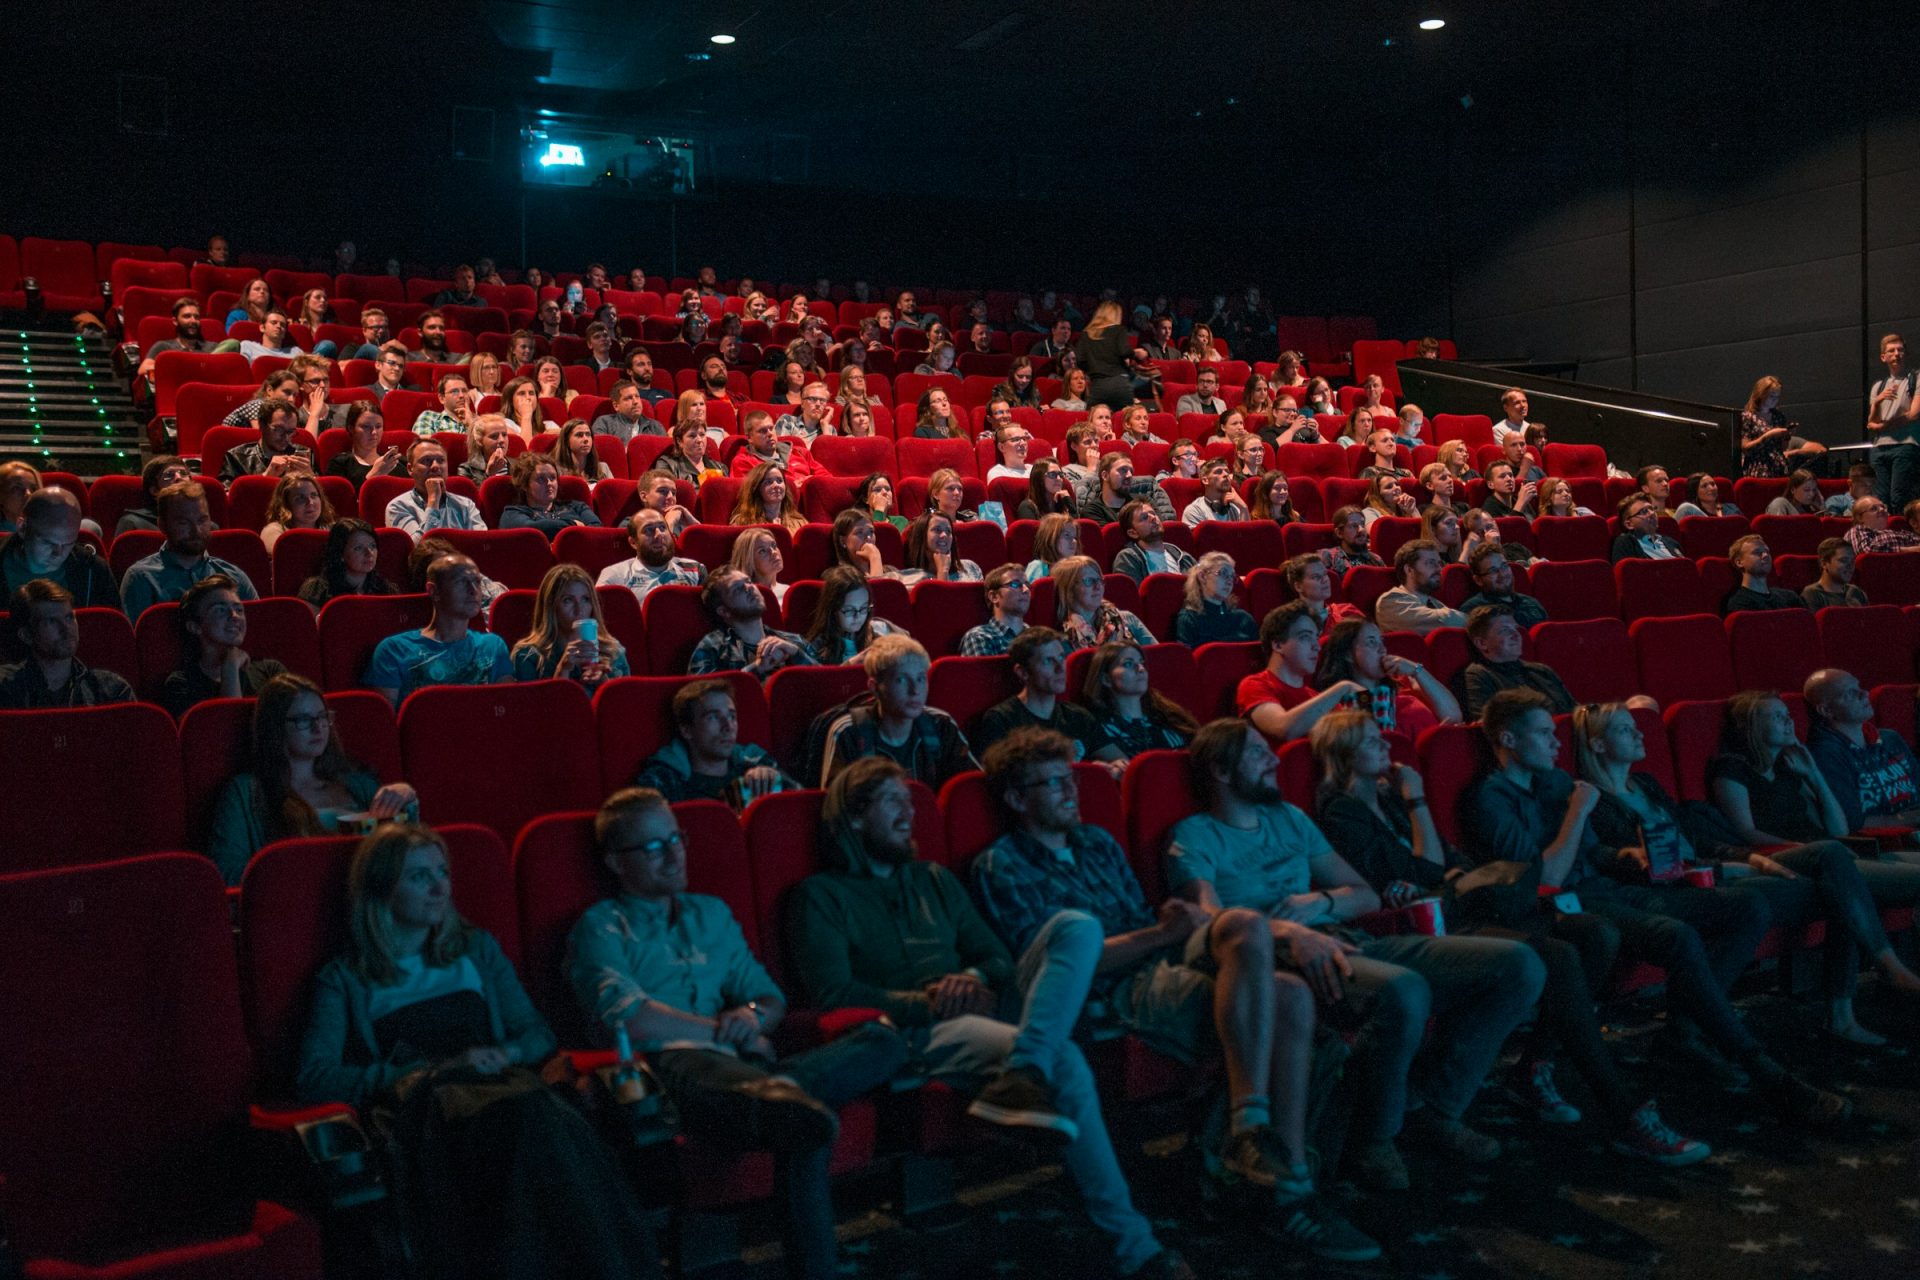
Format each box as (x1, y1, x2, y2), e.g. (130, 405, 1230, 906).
(0, 702, 186, 875)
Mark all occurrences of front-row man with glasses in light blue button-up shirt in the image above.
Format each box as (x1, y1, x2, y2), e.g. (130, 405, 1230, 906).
(566, 787, 906, 1280)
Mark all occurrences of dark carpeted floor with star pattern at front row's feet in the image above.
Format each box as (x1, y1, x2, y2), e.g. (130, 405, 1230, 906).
(714, 988, 1920, 1280)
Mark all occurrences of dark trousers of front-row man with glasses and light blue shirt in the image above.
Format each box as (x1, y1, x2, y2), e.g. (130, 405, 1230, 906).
(653, 1023, 906, 1280)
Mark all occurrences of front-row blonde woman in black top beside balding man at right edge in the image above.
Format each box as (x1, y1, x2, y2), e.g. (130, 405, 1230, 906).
(1697, 691, 1920, 1044)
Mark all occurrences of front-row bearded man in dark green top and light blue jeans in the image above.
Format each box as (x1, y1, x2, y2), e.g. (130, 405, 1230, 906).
(787, 758, 1194, 1280)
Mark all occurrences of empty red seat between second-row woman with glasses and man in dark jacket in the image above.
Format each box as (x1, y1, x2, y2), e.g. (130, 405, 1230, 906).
(399, 679, 601, 839)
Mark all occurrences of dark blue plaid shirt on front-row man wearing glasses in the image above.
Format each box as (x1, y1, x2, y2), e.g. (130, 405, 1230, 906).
(973, 823, 1154, 967)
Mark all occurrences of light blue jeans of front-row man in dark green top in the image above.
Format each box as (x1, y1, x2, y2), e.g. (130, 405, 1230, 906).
(922, 912, 1160, 1272)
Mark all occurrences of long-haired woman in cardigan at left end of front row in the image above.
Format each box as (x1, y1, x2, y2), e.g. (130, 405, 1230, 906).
(296, 823, 660, 1280)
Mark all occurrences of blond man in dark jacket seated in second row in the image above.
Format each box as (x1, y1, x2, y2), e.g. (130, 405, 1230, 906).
(820, 635, 979, 794)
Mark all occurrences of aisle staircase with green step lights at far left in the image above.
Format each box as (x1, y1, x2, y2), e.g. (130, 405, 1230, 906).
(0, 326, 142, 476)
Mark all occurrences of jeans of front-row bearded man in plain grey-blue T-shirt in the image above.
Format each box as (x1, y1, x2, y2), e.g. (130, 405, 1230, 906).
(1342, 935, 1548, 1142)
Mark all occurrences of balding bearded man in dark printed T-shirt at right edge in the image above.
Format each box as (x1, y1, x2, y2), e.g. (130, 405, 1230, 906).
(1801, 668, 1920, 831)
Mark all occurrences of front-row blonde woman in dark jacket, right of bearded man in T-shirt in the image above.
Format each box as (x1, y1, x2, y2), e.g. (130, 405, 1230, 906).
(1311, 710, 1713, 1169)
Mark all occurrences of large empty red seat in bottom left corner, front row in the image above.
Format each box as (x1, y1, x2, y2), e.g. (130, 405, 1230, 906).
(0, 854, 323, 1280)
